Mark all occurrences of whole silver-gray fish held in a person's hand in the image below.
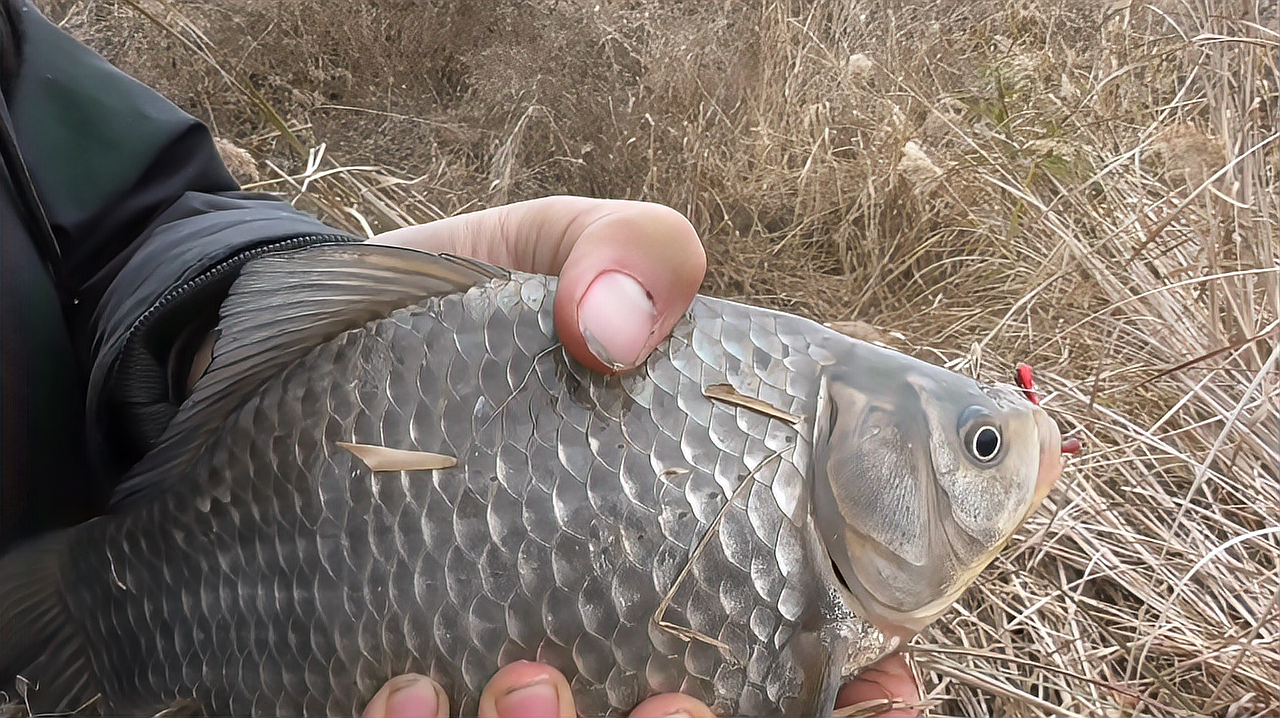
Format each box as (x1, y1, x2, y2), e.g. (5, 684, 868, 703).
(0, 243, 1062, 715)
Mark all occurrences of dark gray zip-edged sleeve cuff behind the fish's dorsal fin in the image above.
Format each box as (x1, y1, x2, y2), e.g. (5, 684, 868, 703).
(87, 192, 358, 480)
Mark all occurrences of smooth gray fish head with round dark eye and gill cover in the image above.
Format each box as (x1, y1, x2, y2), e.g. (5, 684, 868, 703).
(813, 343, 1062, 640)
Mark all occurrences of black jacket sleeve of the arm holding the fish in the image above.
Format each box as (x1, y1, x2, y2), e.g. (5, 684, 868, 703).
(6, 1, 355, 484)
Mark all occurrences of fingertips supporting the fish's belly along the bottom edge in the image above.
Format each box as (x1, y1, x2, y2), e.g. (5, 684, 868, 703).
(364, 655, 919, 718)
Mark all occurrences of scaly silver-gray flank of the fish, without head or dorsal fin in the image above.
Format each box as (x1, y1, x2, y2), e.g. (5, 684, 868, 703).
(57, 275, 884, 714)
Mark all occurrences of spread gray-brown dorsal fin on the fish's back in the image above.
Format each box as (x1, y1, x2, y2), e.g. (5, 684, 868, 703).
(111, 243, 509, 507)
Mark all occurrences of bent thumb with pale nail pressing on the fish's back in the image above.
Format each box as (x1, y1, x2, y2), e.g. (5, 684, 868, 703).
(374, 197, 707, 372)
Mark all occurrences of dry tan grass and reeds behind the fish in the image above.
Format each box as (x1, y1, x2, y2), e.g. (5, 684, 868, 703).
(30, 0, 1280, 717)
